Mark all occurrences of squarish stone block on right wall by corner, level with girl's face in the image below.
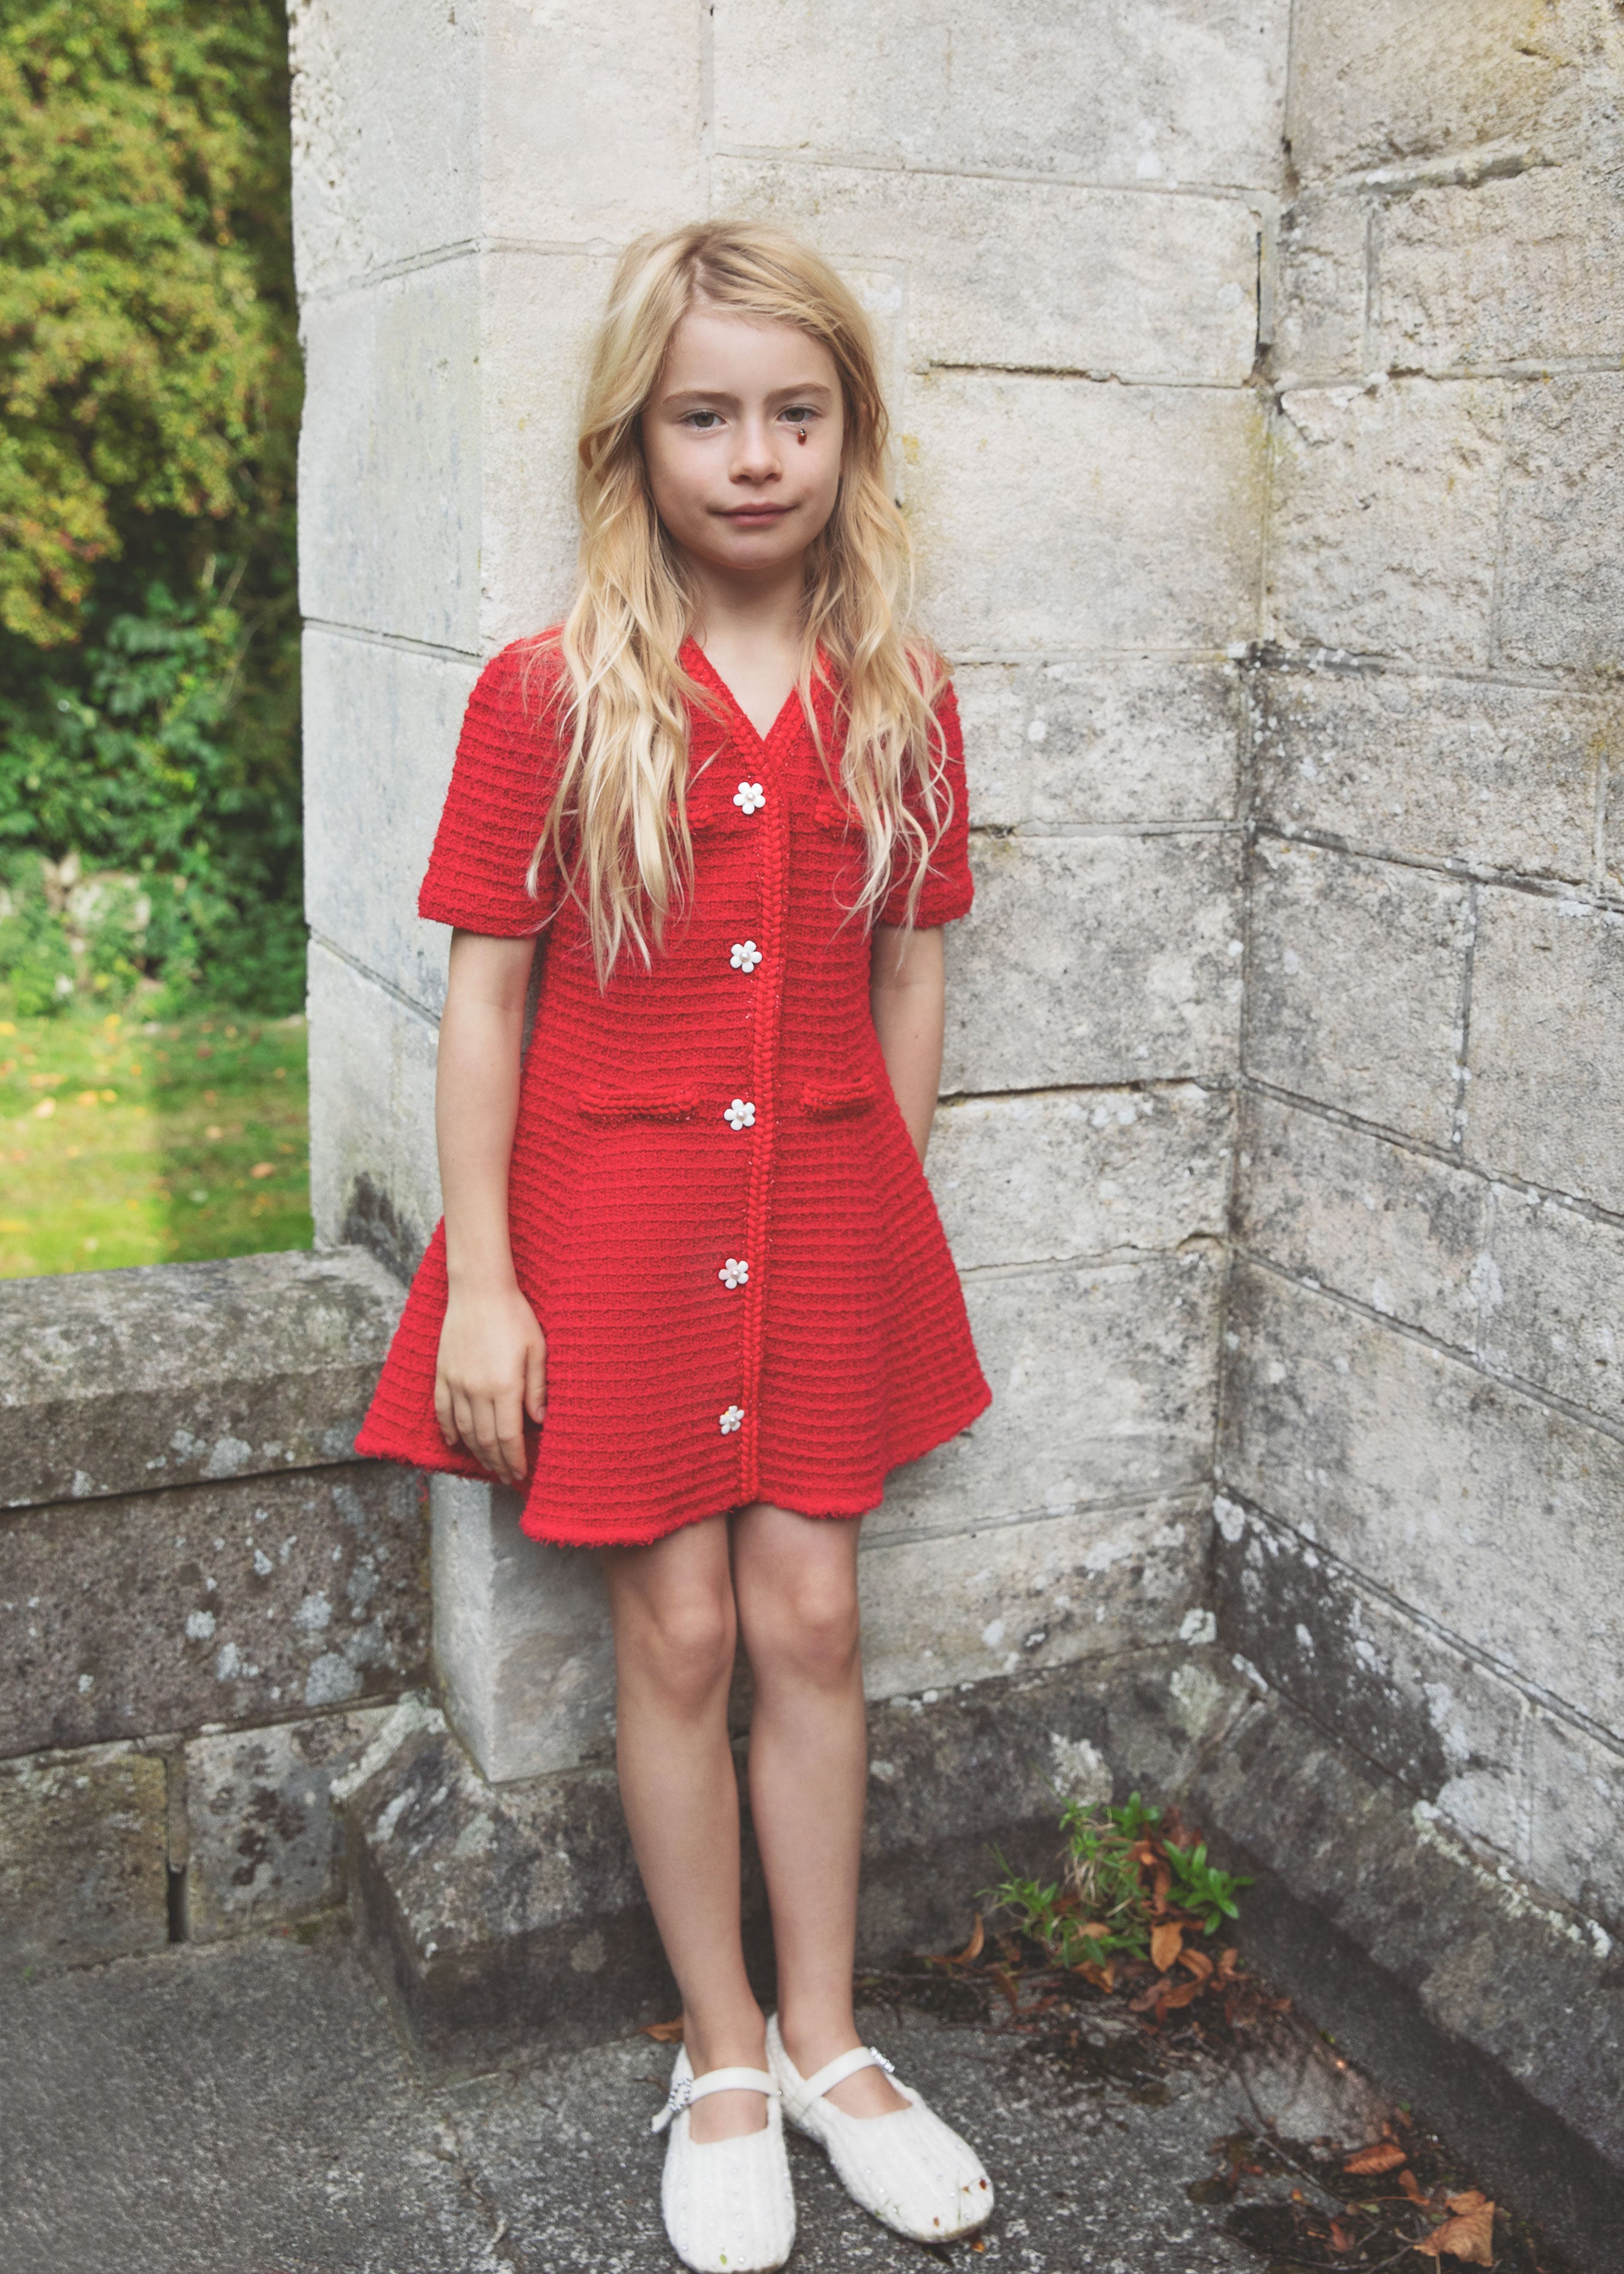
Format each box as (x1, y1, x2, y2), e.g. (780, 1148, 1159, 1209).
(1269, 380, 1504, 667)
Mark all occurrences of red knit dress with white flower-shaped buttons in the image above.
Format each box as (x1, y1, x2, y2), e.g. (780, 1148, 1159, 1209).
(357, 641, 992, 1546)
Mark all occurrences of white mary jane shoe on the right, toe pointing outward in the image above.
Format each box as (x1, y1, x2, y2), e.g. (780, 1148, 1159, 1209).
(766, 2015, 992, 2242)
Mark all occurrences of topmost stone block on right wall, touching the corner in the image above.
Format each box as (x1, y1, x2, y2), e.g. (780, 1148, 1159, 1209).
(1287, 0, 1563, 175)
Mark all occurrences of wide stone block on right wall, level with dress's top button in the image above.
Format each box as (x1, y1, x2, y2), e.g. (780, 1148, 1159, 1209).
(1253, 671, 1619, 880)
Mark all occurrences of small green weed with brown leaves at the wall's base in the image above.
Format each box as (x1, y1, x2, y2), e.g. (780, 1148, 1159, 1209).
(987, 1792, 1251, 1967)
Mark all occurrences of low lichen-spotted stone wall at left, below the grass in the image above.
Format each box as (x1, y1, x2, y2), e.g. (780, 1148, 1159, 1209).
(0, 1248, 430, 1969)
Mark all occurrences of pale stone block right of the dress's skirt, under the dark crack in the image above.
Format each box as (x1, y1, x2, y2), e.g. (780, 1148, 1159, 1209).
(928, 1082, 1233, 1271)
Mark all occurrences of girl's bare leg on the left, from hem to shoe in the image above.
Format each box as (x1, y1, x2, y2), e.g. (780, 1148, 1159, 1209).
(603, 1517, 766, 2140)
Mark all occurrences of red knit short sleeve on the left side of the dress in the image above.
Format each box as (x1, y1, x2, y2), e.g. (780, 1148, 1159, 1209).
(416, 641, 557, 939)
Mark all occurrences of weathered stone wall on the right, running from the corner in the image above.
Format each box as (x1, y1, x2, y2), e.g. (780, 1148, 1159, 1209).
(1217, 0, 1624, 1930)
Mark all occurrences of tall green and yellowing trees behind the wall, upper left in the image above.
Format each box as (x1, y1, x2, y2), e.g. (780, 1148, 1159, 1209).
(0, 0, 303, 1012)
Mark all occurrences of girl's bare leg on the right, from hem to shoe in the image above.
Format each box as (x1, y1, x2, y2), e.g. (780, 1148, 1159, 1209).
(733, 1501, 908, 2117)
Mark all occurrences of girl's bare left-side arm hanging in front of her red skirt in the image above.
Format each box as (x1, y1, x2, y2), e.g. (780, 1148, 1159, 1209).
(434, 932, 546, 1485)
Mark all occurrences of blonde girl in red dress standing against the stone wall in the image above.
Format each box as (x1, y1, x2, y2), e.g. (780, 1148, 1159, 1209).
(359, 223, 992, 2274)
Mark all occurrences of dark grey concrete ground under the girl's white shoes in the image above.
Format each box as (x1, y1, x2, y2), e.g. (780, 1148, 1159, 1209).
(0, 1933, 1401, 2274)
